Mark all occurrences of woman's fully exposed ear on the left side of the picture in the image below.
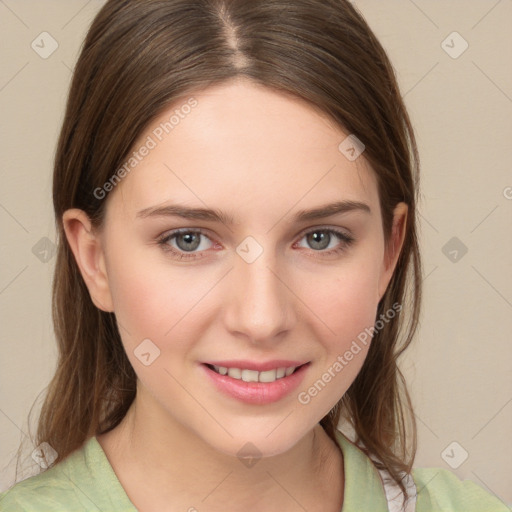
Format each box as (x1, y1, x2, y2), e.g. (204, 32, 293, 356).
(62, 208, 114, 312)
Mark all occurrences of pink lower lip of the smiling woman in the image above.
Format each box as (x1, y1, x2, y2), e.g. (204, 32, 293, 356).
(201, 363, 309, 405)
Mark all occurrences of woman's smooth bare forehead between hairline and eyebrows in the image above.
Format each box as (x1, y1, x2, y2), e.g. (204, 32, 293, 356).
(111, 80, 378, 221)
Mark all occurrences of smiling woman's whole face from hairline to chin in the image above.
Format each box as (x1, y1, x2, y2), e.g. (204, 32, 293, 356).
(65, 81, 406, 455)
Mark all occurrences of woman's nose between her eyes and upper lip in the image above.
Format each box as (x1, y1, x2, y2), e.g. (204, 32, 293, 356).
(223, 250, 297, 345)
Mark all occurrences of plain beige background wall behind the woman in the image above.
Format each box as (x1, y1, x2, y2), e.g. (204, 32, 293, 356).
(0, 0, 512, 504)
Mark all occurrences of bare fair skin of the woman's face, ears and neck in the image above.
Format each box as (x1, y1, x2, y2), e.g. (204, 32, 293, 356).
(63, 79, 407, 512)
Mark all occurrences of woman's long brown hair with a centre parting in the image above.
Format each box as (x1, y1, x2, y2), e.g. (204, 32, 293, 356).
(20, 0, 421, 504)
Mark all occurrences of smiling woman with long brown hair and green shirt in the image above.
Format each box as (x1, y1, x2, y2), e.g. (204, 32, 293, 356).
(0, 0, 505, 512)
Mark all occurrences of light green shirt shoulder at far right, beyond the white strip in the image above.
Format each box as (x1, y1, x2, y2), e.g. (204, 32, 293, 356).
(412, 468, 510, 512)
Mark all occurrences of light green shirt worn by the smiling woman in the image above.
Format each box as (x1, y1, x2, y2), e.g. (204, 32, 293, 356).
(0, 432, 510, 512)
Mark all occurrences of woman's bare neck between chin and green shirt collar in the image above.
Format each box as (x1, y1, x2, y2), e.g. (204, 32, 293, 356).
(98, 388, 343, 512)
